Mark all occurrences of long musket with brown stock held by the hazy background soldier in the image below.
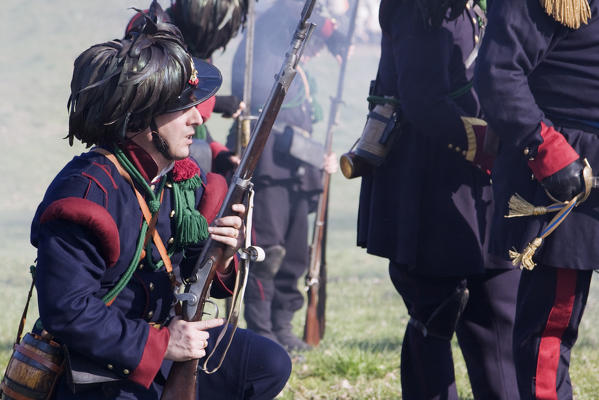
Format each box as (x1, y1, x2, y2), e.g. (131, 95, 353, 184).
(304, 0, 360, 346)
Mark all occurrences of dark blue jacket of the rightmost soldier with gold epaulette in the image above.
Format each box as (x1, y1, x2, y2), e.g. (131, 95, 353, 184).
(475, 0, 599, 269)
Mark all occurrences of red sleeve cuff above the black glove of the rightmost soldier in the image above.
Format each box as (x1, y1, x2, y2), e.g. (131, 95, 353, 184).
(528, 122, 580, 181)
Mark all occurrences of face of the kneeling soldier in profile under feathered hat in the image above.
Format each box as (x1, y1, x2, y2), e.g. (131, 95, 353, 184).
(152, 107, 203, 161)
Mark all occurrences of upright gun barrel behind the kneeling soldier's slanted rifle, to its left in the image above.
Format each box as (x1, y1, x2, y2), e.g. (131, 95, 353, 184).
(235, 0, 256, 156)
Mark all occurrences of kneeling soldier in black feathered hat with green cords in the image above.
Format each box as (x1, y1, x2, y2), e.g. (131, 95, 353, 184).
(24, 19, 291, 399)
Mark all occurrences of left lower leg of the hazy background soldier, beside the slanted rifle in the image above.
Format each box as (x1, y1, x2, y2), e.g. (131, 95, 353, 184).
(243, 246, 285, 342)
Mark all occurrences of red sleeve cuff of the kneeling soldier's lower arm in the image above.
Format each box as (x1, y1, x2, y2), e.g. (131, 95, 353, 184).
(129, 327, 170, 389)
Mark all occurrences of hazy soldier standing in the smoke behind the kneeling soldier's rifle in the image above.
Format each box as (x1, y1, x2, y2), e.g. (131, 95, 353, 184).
(228, 0, 342, 350)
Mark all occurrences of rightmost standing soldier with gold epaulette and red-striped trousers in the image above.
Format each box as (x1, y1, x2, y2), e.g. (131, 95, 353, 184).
(475, 0, 599, 399)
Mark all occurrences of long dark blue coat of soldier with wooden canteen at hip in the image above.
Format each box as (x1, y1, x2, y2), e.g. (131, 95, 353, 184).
(358, 0, 507, 277)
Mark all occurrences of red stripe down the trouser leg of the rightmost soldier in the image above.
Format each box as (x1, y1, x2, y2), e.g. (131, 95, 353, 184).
(535, 268, 577, 400)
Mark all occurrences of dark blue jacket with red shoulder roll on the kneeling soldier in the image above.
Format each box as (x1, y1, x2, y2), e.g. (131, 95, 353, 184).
(31, 144, 234, 387)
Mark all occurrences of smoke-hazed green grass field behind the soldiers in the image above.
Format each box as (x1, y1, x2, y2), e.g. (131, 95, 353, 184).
(0, 0, 599, 400)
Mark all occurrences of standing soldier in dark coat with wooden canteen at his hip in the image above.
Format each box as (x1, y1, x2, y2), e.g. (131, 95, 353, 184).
(358, 0, 519, 400)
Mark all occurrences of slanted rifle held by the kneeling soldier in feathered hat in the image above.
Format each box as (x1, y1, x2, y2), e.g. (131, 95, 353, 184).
(161, 0, 316, 400)
